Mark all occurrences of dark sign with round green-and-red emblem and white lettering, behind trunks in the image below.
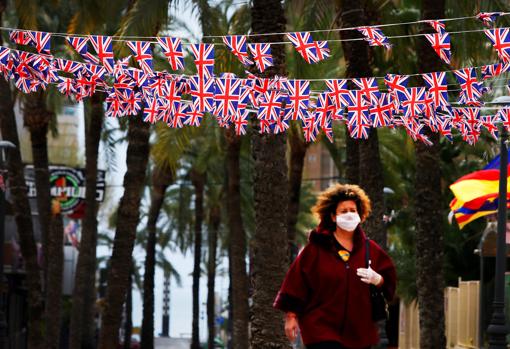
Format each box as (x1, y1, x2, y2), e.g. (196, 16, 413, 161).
(25, 166, 105, 214)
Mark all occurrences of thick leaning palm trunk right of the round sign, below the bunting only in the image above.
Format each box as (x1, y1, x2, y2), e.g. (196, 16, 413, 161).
(99, 115, 150, 349)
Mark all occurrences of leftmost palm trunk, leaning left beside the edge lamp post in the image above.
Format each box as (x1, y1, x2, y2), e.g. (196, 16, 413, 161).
(0, 64, 45, 349)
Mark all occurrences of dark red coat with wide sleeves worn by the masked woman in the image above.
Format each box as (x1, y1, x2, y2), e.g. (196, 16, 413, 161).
(273, 224, 396, 348)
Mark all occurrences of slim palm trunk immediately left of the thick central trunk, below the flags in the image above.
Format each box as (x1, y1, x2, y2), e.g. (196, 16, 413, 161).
(225, 128, 249, 349)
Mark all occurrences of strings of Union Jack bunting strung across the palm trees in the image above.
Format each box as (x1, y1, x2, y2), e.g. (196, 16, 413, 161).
(0, 13, 510, 144)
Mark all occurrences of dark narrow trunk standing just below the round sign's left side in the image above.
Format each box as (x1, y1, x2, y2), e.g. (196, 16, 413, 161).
(45, 213, 64, 349)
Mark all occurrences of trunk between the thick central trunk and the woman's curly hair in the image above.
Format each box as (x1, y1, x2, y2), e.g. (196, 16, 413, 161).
(287, 126, 309, 262)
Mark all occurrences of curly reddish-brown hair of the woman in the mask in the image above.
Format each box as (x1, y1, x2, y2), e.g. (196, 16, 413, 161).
(312, 184, 372, 231)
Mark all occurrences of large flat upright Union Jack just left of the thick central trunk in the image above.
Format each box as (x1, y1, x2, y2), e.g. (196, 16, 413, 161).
(214, 79, 241, 122)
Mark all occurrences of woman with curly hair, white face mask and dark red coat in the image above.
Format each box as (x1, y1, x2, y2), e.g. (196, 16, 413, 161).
(273, 184, 396, 349)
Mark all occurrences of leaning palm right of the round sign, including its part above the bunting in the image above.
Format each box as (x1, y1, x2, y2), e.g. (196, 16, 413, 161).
(99, 0, 169, 349)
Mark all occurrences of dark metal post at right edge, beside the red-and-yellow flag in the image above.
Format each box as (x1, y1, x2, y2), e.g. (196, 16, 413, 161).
(488, 120, 508, 349)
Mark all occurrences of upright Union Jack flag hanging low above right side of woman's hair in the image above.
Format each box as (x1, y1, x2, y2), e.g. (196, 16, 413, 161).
(347, 90, 372, 139)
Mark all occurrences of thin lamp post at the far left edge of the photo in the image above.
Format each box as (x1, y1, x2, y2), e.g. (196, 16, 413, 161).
(0, 141, 16, 348)
